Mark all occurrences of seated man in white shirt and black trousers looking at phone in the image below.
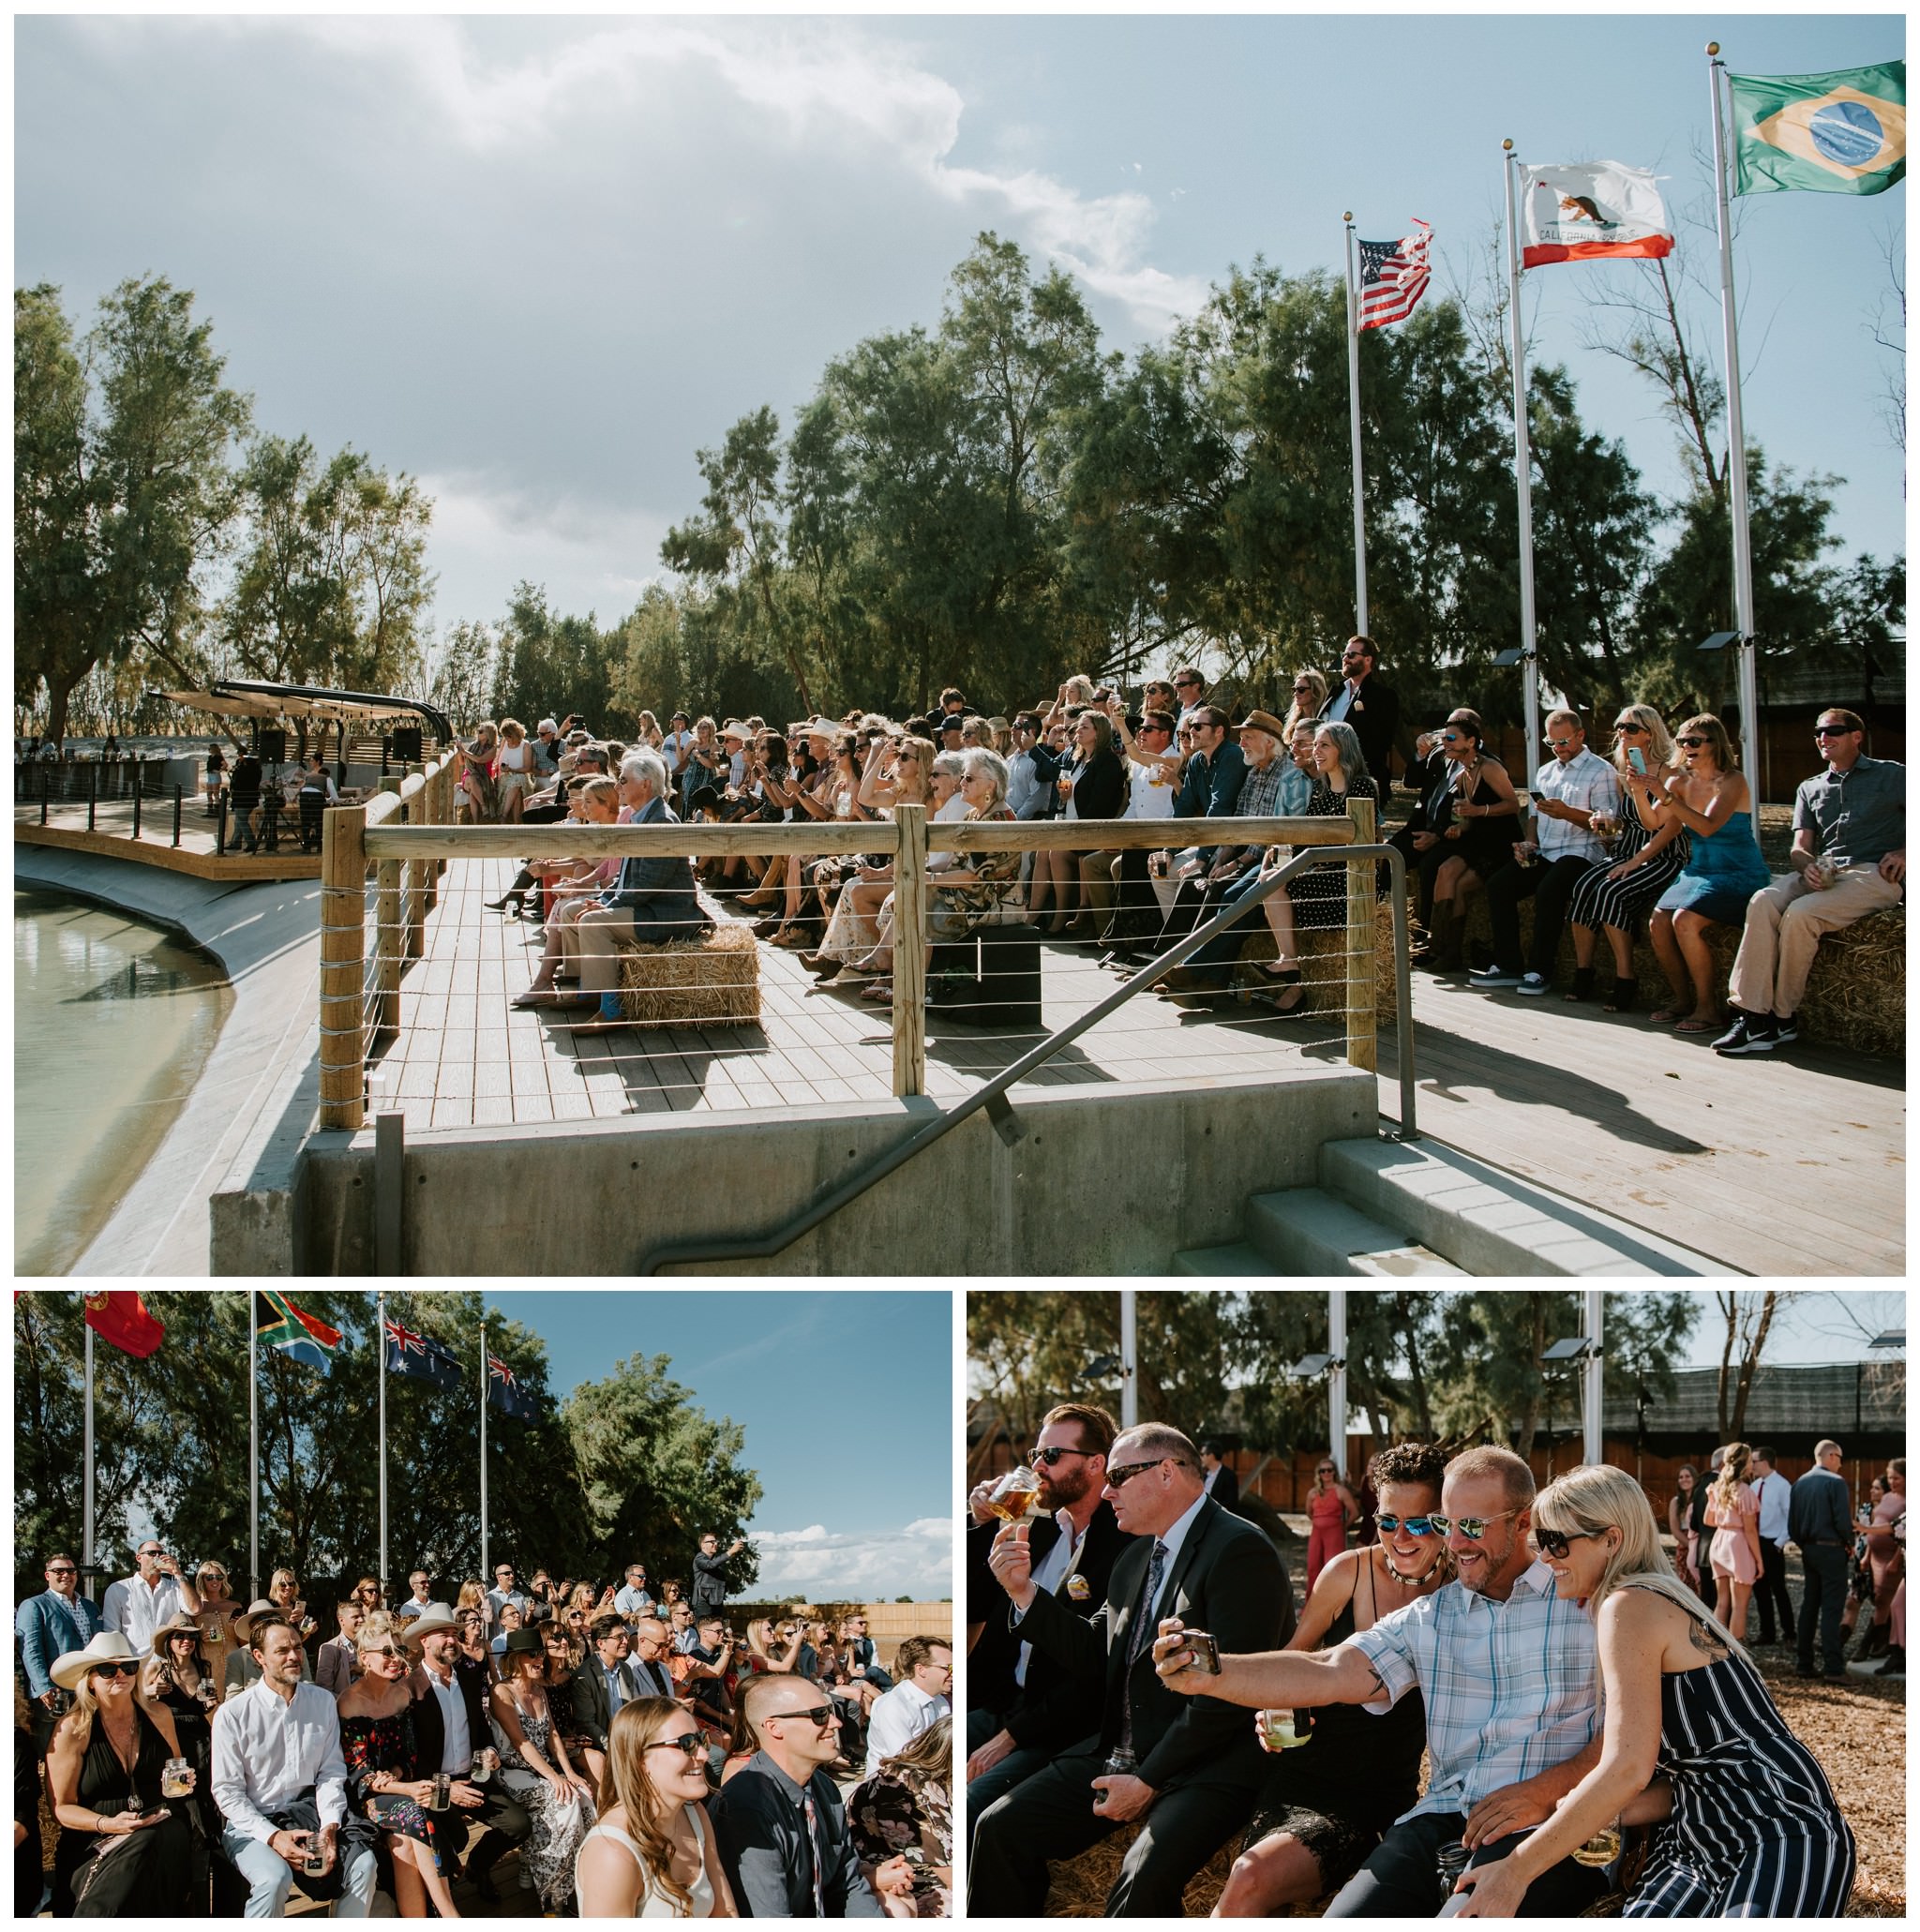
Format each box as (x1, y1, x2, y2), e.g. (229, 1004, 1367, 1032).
(1468, 711, 1621, 999)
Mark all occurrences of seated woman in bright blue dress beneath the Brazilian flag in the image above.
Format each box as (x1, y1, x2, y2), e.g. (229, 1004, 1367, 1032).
(1632, 717, 1773, 1034)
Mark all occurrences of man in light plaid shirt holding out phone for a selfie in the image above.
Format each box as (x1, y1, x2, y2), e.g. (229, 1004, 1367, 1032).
(1155, 1447, 1607, 1919)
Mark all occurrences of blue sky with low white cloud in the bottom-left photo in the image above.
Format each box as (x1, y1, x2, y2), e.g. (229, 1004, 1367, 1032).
(487, 1289, 954, 1597)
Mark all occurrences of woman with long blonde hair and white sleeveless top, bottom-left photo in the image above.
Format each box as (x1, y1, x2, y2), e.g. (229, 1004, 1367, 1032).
(574, 1697, 738, 1919)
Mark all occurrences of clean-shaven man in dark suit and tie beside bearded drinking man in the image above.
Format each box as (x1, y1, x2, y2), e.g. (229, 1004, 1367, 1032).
(968, 1422, 1286, 1919)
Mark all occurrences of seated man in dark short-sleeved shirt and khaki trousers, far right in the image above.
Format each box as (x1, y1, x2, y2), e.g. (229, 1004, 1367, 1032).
(1714, 711, 1907, 1055)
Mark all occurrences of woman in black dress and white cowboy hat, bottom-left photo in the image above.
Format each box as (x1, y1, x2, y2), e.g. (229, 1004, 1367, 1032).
(46, 1630, 204, 1919)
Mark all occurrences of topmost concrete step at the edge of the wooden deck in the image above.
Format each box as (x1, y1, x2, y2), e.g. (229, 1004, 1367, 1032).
(1313, 1140, 1734, 1275)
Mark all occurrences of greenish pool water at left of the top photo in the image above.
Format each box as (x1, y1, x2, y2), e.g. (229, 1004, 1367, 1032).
(13, 889, 233, 1275)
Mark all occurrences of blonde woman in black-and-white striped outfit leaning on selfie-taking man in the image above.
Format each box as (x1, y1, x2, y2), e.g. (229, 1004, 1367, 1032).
(1457, 1468, 1854, 1919)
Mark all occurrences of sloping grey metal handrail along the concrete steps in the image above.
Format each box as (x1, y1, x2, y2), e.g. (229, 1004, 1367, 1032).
(636, 845, 1419, 1275)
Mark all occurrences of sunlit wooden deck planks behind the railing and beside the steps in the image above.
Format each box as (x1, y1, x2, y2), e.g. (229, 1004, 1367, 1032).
(347, 860, 1907, 1277)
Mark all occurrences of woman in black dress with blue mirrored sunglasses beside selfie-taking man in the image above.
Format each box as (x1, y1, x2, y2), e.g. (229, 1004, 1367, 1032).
(1213, 1444, 1452, 1919)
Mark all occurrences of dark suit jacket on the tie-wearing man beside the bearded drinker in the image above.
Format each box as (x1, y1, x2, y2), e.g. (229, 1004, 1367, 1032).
(1020, 1497, 1286, 1791)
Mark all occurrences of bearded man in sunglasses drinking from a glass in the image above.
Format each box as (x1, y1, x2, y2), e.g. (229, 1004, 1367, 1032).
(966, 1402, 1126, 1818)
